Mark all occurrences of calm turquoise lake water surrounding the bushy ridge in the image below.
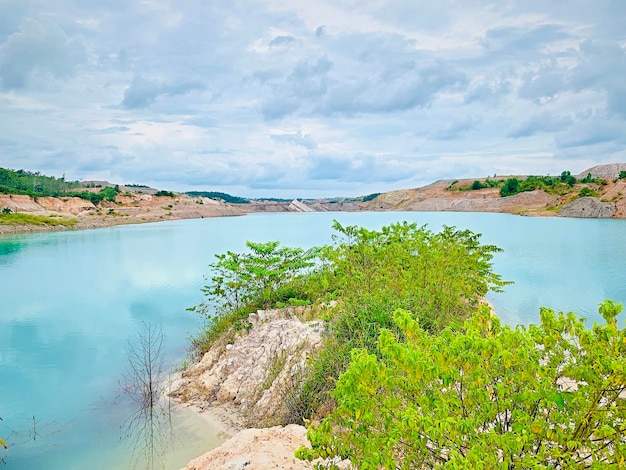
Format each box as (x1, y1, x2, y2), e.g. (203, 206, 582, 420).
(0, 212, 626, 470)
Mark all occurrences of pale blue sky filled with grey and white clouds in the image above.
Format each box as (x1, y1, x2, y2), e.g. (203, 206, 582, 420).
(0, 0, 626, 197)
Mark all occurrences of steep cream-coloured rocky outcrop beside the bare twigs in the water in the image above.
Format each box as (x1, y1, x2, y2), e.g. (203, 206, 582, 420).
(173, 307, 323, 427)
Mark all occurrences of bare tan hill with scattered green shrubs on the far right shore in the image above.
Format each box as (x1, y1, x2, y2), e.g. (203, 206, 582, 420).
(363, 163, 626, 219)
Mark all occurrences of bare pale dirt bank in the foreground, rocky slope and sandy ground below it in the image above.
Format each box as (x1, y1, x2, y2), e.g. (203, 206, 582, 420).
(172, 306, 347, 470)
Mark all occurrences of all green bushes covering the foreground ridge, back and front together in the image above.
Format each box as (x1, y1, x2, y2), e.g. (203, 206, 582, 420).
(190, 222, 626, 469)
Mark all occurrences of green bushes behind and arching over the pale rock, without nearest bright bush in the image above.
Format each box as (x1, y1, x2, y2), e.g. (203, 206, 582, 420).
(192, 221, 507, 423)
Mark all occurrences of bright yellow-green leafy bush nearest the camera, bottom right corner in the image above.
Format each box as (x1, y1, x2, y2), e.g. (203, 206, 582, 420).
(296, 301, 626, 470)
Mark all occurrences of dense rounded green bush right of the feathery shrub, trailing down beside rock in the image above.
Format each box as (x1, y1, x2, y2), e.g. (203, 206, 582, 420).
(288, 221, 506, 422)
